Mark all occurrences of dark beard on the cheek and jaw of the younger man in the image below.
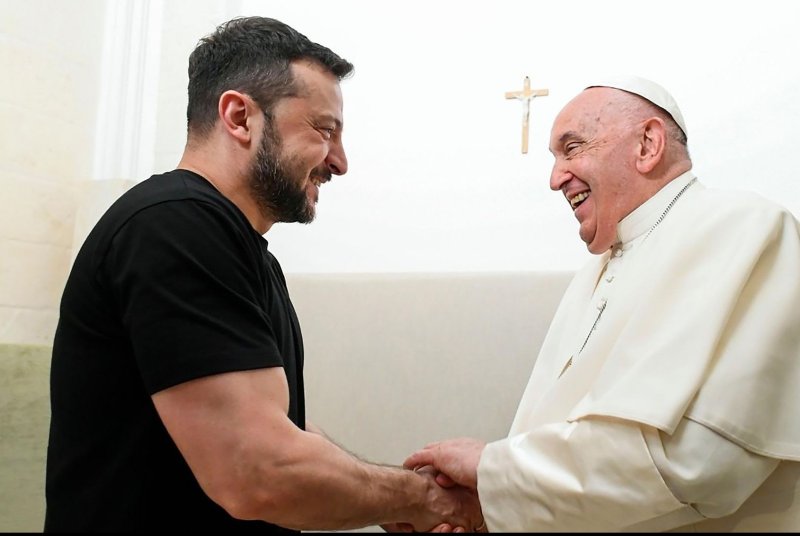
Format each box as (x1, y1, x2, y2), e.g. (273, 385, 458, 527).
(250, 124, 316, 223)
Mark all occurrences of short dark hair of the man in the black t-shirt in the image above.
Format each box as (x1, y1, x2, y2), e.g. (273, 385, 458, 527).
(186, 17, 353, 137)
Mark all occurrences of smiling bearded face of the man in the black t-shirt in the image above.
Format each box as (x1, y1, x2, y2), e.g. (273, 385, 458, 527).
(250, 62, 347, 223)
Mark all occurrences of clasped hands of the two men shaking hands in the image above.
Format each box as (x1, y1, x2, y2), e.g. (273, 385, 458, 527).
(381, 438, 487, 532)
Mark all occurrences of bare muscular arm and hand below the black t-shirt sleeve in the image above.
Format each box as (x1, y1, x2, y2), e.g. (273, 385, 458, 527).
(153, 367, 479, 530)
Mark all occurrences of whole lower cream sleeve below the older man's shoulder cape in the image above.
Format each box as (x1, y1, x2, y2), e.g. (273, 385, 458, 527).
(478, 419, 778, 532)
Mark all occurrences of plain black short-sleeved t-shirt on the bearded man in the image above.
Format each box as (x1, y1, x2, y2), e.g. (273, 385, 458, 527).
(44, 170, 305, 532)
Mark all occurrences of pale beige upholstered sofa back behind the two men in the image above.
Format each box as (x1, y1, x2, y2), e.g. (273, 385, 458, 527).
(0, 272, 572, 532)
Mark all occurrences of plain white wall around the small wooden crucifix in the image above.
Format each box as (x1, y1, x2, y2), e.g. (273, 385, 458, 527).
(216, 0, 800, 272)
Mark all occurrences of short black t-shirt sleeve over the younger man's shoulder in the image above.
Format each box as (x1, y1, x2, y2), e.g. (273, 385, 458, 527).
(98, 200, 283, 394)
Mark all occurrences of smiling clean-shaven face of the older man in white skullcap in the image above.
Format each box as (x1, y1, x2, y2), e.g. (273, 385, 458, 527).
(550, 88, 647, 254)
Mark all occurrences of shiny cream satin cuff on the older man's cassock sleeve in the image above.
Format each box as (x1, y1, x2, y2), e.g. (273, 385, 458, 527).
(478, 419, 684, 532)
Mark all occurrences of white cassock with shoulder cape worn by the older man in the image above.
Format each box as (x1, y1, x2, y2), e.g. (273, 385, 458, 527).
(478, 172, 800, 532)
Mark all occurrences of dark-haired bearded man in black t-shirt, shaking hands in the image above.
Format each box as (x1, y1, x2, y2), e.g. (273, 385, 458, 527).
(44, 17, 481, 532)
